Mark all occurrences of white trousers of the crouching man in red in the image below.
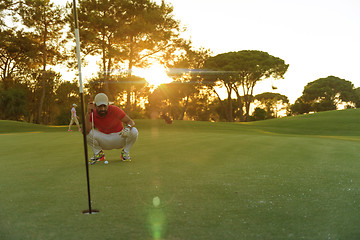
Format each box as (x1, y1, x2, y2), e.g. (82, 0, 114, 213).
(87, 127, 139, 154)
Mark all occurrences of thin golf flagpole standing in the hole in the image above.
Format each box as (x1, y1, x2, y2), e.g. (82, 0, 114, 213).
(73, 0, 98, 214)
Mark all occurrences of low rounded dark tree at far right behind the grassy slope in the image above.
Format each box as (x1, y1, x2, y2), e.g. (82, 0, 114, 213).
(301, 76, 357, 112)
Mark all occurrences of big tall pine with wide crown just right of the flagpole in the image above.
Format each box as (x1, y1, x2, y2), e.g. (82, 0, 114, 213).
(68, 0, 183, 113)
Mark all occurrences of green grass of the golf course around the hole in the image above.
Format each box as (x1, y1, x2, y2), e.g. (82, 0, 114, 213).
(0, 110, 360, 240)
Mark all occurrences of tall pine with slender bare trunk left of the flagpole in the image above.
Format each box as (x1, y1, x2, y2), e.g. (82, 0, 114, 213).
(17, 0, 65, 123)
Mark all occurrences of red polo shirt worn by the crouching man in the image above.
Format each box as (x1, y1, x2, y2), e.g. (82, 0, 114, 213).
(90, 105, 126, 134)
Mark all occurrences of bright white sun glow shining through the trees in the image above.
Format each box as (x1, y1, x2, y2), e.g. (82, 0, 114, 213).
(134, 63, 173, 88)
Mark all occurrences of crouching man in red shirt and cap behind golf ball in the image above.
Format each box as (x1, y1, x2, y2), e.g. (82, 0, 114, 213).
(85, 93, 138, 164)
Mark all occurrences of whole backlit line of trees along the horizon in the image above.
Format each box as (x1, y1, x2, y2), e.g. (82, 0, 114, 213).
(0, 0, 360, 124)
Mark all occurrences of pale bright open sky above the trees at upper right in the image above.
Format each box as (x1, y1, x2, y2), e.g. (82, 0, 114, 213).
(67, 0, 360, 103)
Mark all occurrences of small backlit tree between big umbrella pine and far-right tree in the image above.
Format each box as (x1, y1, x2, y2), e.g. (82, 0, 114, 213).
(255, 92, 289, 119)
